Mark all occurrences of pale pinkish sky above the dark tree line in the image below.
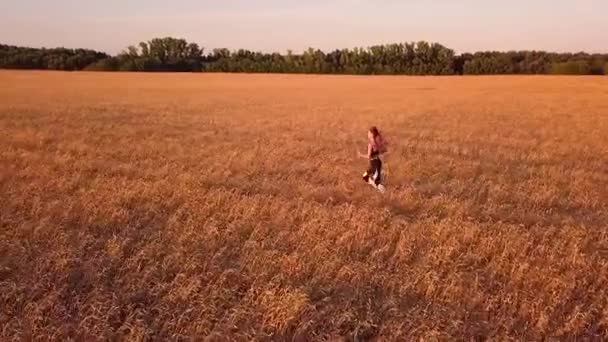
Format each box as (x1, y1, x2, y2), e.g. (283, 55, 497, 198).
(0, 0, 608, 53)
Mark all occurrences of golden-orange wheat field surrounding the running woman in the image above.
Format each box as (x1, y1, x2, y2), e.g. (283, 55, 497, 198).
(0, 72, 608, 341)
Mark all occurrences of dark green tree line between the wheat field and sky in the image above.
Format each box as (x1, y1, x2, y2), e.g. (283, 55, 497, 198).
(0, 37, 608, 75)
